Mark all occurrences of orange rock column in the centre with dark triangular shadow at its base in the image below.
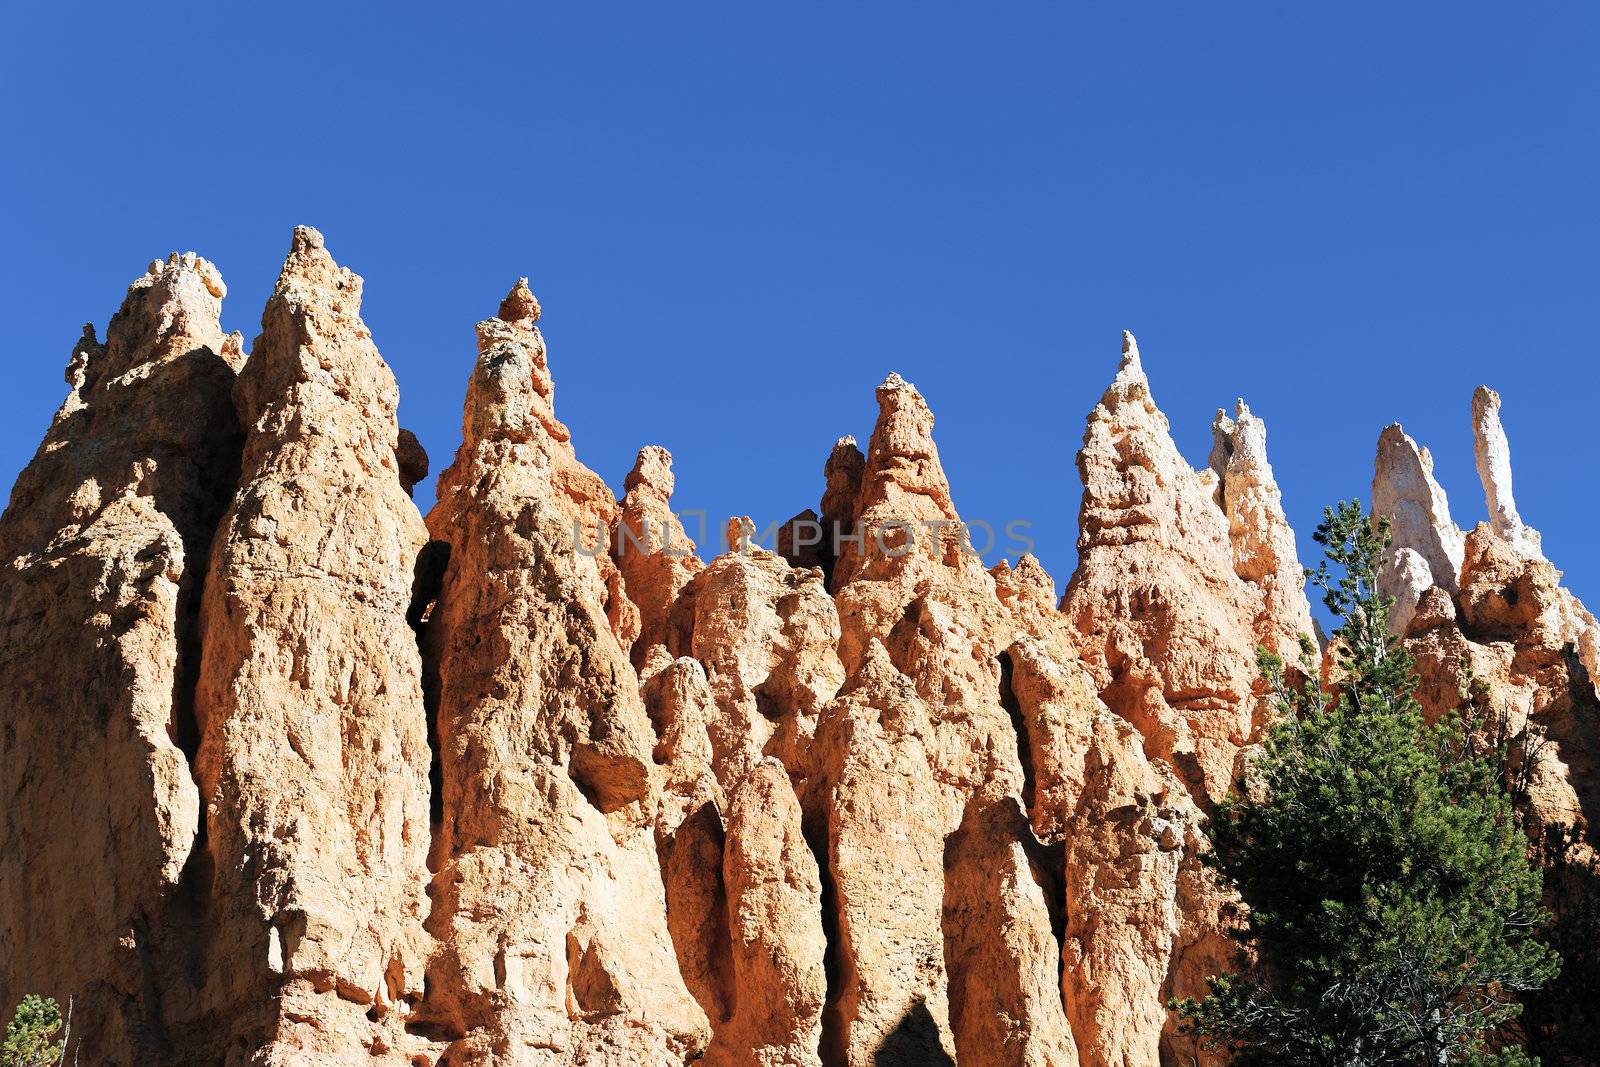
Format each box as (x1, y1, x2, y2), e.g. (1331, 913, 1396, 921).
(808, 374, 1070, 1067)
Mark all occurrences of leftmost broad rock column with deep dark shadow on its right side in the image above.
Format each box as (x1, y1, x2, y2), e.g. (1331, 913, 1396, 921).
(0, 253, 243, 1064)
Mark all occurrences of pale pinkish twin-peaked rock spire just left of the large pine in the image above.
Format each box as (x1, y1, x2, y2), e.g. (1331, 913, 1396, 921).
(1061, 334, 1309, 808)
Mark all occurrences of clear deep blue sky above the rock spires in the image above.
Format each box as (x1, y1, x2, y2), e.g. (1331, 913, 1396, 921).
(0, 3, 1600, 608)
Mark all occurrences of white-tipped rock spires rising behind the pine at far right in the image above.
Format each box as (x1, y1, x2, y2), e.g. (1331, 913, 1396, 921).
(1373, 386, 1600, 857)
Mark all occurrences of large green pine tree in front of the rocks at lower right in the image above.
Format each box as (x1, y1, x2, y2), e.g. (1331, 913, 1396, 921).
(1173, 502, 1558, 1067)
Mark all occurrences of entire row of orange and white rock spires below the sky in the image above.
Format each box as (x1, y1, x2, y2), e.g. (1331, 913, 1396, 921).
(0, 227, 1600, 1067)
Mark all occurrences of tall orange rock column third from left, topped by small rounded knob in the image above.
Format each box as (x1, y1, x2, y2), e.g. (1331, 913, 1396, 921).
(424, 283, 710, 1067)
